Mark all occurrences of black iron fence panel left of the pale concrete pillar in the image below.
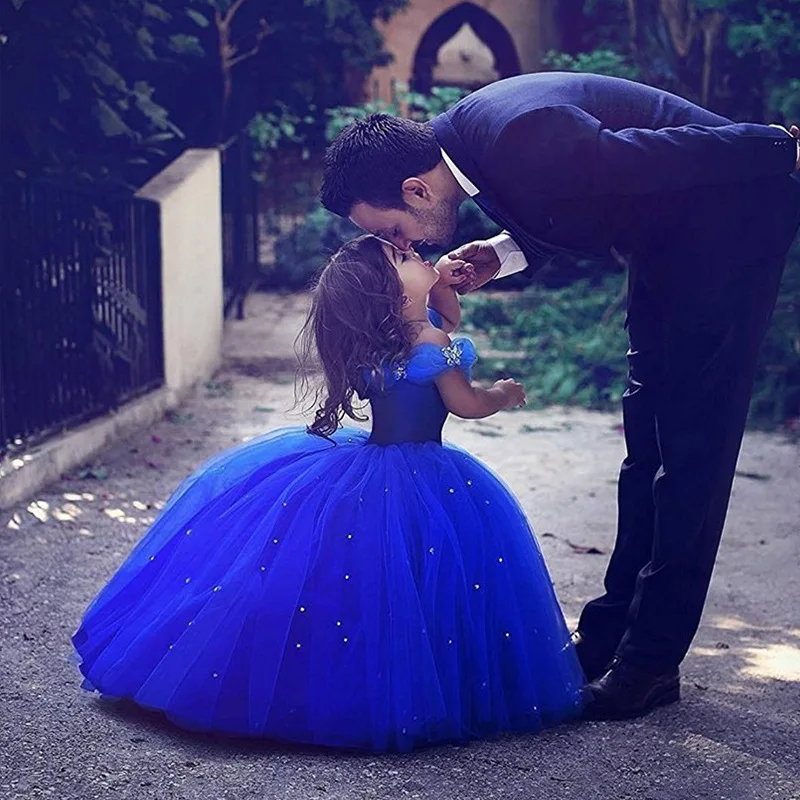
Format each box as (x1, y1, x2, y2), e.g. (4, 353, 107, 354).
(0, 180, 163, 455)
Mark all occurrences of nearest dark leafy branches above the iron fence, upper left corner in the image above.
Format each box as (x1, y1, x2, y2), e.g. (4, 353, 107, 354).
(0, 0, 191, 183)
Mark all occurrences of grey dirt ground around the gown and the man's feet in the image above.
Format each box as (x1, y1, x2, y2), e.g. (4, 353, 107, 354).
(0, 295, 800, 800)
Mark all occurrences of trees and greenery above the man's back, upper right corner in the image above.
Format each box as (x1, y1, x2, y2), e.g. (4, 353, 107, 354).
(544, 0, 800, 122)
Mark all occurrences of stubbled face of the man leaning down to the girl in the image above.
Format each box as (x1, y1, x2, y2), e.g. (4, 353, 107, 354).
(350, 199, 458, 251)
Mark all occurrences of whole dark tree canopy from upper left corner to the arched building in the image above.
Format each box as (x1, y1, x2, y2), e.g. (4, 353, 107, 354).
(0, 0, 405, 185)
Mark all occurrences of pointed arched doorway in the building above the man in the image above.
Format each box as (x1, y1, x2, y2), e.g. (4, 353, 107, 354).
(411, 3, 522, 94)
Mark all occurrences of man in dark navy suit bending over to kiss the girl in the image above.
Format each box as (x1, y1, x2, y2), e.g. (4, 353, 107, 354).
(321, 73, 800, 719)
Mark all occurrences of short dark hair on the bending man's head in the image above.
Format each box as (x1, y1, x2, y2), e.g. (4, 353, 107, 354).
(320, 114, 442, 217)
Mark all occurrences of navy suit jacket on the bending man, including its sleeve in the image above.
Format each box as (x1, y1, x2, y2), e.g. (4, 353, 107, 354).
(431, 72, 800, 266)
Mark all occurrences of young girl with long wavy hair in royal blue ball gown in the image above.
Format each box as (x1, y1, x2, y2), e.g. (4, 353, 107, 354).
(73, 231, 583, 750)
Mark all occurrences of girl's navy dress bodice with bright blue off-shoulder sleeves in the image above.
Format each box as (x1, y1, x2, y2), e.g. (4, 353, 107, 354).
(365, 309, 477, 445)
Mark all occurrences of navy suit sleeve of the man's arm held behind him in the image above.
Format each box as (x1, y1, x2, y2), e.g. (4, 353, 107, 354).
(492, 105, 797, 198)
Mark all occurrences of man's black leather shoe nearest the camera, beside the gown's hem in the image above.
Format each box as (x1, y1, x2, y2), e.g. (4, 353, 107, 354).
(583, 658, 681, 720)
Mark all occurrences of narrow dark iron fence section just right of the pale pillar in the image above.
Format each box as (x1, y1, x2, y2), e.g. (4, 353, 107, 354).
(221, 132, 259, 319)
